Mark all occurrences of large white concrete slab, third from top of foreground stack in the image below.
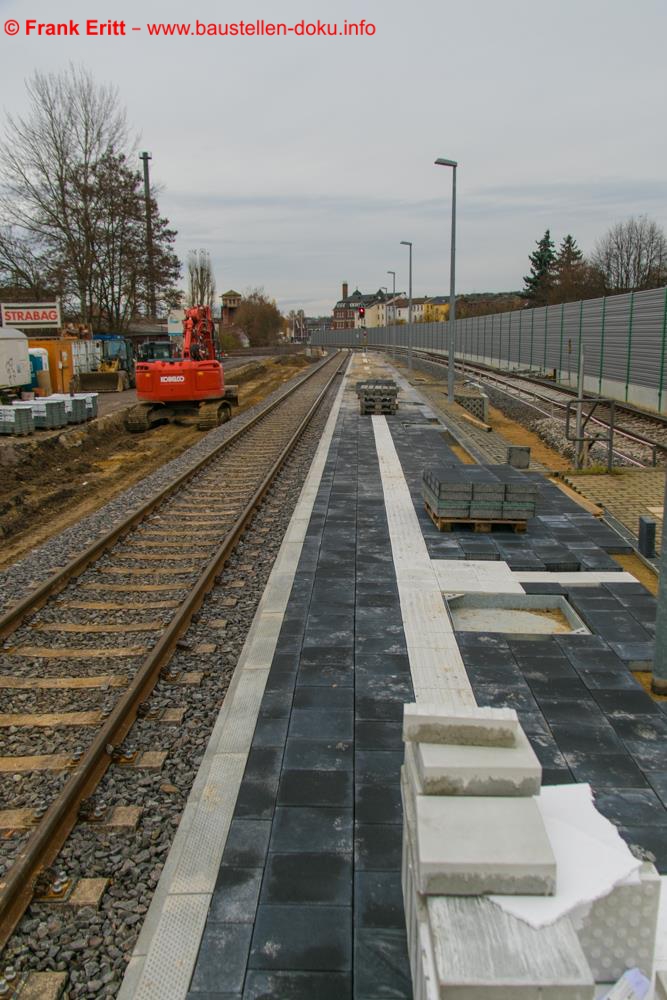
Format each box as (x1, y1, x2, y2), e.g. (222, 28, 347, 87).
(404, 788, 556, 896)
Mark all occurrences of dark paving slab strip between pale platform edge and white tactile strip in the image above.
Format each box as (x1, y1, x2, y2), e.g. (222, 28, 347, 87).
(183, 403, 414, 1000)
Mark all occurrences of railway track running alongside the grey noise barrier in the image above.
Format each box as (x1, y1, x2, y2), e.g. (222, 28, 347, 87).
(396, 351, 667, 468)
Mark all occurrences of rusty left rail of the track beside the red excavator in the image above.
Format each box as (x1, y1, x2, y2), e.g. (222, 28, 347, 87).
(0, 355, 336, 639)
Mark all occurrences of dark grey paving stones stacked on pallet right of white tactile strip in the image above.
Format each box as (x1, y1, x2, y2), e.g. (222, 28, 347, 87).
(422, 465, 538, 522)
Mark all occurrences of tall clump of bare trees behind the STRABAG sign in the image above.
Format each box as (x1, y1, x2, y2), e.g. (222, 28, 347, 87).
(0, 65, 180, 330)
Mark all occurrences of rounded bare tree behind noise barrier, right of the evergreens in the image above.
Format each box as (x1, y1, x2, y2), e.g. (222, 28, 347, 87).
(591, 215, 667, 292)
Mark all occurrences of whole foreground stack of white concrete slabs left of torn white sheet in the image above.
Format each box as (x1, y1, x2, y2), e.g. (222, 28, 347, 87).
(401, 704, 594, 1000)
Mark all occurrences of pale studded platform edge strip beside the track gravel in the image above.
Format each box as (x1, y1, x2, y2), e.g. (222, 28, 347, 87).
(117, 370, 346, 1000)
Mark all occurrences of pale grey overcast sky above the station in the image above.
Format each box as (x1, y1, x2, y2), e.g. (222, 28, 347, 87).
(0, 0, 667, 314)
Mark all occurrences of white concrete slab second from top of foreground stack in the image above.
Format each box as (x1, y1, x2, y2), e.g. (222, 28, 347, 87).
(405, 730, 542, 796)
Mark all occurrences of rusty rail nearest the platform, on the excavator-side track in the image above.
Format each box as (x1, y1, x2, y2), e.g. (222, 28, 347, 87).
(0, 358, 347, 948)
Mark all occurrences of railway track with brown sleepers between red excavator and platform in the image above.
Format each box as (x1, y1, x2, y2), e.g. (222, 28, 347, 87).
(0, 355, 347, 947)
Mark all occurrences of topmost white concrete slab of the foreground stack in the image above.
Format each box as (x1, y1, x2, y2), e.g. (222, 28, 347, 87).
(403, 702, 521, 747)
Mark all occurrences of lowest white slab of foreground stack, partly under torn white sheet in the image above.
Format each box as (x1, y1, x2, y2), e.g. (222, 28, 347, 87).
(427, 896, 595, 1000)
